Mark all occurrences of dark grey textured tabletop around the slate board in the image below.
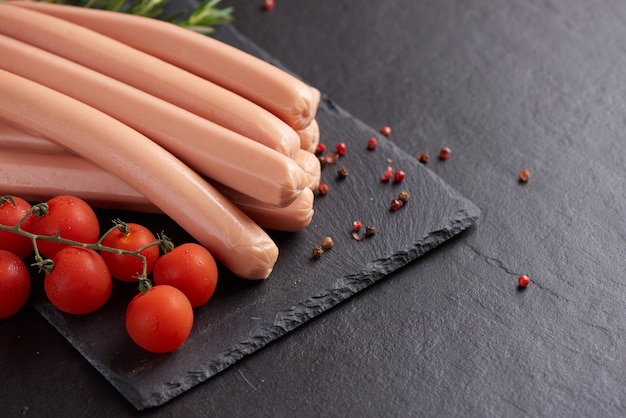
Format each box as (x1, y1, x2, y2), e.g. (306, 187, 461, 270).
(0, 0, 626, 417)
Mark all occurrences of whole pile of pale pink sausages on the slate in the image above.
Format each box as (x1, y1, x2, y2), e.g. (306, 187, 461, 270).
(0, 0, 320, 279)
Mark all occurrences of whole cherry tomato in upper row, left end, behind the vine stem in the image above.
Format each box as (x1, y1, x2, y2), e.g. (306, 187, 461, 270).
(24, 195, 100, 258)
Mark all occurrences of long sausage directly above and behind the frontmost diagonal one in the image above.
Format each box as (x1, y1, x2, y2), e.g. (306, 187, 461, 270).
(0, 31, 307, 206)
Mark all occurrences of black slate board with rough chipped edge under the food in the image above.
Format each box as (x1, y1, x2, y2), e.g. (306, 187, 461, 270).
(26, 26, 480, 409)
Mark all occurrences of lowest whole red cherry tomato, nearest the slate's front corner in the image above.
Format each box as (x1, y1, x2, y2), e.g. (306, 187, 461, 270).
(126, 285, 193, 353)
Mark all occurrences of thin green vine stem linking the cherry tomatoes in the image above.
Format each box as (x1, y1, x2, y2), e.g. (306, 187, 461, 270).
(0, 196, 169, 284)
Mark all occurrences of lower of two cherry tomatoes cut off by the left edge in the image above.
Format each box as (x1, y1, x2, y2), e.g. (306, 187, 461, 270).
(0, 250, 30, 319)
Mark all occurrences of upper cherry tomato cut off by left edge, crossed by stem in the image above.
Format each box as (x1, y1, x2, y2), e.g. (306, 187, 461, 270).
(0, 196, 34, 258)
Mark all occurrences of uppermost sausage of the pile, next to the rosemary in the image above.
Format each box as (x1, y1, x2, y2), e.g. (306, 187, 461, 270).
(12, 1, 320, 130)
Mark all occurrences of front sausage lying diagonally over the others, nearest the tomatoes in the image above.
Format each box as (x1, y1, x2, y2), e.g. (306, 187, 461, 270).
(0, 69, 278, 279)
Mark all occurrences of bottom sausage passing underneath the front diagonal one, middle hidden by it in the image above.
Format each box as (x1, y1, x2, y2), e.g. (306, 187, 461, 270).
(0, 145, 314, 232)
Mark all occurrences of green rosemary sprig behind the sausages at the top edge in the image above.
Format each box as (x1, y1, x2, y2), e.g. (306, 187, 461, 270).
(39, 0, 233, 34)
